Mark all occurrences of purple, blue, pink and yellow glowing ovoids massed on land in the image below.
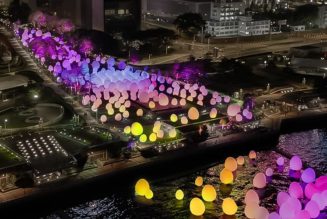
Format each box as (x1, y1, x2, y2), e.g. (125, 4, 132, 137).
(15, 24, 252, 145)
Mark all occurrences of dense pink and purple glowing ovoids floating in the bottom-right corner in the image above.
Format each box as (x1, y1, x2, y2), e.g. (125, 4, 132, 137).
(244, 156, 327, 219)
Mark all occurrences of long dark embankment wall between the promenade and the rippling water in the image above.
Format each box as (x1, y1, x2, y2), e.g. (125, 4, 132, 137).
(0, 110, 327, 217)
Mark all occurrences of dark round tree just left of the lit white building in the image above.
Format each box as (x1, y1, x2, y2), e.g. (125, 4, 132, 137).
(174, 13, 205, 35)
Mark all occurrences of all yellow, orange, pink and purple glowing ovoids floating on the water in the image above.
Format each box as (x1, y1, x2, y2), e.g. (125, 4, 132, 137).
(135, 151, 327, 219)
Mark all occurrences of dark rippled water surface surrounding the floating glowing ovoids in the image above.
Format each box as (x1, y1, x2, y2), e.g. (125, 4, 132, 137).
(43, 129, 327, 219)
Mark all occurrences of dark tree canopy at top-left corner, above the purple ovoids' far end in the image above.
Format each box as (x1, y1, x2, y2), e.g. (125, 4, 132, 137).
(8, 0, 31, 24)
